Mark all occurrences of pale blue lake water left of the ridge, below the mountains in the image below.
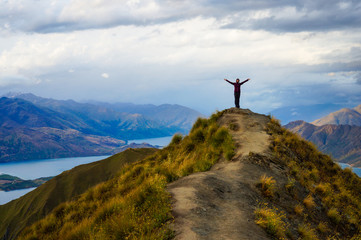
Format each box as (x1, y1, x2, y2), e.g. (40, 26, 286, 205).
(0, 136, 173, 205)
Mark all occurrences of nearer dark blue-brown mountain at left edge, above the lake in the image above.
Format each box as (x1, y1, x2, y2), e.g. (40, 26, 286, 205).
(0, 98, 126, 162)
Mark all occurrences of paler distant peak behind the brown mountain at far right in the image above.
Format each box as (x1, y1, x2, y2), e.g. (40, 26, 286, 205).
(312, 105, 361, 126)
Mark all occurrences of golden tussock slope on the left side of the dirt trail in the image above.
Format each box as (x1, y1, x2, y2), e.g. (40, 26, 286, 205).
(20, 114, 234, 239)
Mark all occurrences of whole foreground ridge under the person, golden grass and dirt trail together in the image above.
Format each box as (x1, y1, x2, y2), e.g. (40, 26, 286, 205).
(2, 108, 361, 239)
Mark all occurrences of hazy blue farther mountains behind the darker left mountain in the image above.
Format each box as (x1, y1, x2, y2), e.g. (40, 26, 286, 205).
(7, 93, 201, 140)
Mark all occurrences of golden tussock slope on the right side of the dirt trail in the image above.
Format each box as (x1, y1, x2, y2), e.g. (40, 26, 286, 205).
(255, 120, 361, 240)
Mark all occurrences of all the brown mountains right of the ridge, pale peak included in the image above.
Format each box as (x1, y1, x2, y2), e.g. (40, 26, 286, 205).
(285, 105, 361, 167)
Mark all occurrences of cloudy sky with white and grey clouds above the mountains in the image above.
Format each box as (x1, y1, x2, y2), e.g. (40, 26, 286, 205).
(0, 0, 361, 114)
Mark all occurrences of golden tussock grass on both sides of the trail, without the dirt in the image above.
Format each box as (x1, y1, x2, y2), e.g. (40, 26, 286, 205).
(4, 109, 361, 239)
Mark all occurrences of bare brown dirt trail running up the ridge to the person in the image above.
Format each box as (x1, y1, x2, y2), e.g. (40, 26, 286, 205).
(168, 108, 269, 240)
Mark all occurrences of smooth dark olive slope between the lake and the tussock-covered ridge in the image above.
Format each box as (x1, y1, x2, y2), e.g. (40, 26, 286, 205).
(0, 148, 157, 239)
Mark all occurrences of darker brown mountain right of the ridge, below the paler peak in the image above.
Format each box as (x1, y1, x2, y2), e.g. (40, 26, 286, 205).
(285, 121, 361, 167)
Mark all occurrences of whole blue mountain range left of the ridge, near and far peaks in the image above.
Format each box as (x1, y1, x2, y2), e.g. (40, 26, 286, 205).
(0, 94, 201, 162)
